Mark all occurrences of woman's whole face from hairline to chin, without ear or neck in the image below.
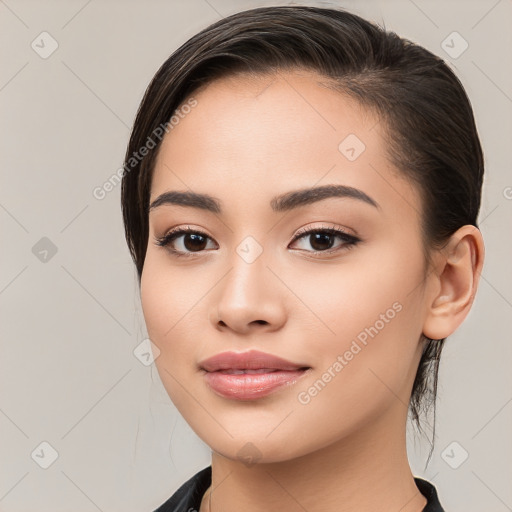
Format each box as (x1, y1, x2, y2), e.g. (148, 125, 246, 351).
(141, 72, 429, 462)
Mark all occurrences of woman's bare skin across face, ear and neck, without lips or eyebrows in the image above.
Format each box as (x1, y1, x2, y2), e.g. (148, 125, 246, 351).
(141, 71, 483, 512)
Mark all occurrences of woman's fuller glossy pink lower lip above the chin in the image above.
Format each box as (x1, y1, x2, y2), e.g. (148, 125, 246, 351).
(204, 370, 307, 400)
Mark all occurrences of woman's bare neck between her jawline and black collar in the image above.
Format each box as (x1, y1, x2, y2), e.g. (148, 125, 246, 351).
(200, 401, 427, 512)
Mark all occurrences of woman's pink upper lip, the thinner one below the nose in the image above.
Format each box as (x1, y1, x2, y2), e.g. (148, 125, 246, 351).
(199, 350, 308, 372)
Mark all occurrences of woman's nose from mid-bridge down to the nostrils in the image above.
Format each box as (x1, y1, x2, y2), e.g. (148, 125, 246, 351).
(210, 248, 286, 334)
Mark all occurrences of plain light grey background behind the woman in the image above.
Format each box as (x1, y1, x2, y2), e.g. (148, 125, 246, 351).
(0, 0, 512, 512)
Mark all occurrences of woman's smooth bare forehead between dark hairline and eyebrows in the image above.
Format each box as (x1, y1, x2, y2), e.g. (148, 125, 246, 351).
(150, 71, 422, 224)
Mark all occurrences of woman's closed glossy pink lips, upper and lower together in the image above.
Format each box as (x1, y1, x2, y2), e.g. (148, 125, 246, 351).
(199, 350, 311, 400)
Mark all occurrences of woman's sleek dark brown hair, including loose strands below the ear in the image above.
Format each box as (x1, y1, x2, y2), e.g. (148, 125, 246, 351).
(121, 6, 484, 464)
